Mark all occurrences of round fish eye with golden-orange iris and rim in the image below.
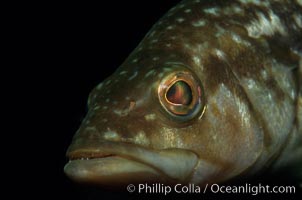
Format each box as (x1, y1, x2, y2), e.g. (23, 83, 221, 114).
(158, 70, 205, 121)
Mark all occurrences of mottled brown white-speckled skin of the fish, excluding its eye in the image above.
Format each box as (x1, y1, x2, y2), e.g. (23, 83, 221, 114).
(65, 0, 302, 188)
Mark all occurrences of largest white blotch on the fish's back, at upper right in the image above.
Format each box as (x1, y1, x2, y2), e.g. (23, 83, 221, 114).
(246, 10, 287, 38)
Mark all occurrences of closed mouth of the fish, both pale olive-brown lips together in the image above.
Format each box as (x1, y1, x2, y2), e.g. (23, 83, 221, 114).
(64, 141, 198, 186)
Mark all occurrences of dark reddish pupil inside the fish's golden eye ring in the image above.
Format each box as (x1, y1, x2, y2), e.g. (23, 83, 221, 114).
(166, 81, 192, 105)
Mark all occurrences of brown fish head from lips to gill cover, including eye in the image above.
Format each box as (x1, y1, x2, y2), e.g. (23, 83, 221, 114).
(65, 1, 265, 188)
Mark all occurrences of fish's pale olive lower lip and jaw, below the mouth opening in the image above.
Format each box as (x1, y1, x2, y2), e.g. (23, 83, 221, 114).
(64, 156, 170, 187)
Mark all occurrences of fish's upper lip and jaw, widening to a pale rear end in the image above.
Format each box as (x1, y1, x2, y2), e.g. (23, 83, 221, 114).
(67, 140, 198, 181)
